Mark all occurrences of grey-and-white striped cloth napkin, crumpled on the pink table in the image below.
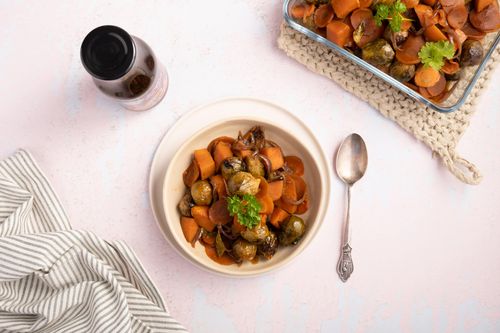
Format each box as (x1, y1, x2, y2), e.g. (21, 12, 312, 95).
(0, 151, 186, 333)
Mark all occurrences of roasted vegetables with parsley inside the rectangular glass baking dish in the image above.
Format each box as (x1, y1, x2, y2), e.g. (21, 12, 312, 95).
(290, 0, 500, 103)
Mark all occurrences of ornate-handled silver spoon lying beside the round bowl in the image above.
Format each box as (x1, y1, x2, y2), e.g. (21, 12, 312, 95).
(335, 133, 368, 282)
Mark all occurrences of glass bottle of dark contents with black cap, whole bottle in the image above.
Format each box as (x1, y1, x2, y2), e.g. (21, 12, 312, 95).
(80, 25, 168, 111)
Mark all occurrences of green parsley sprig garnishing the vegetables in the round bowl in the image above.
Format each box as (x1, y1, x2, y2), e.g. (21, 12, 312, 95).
(227, 194, 261, 229)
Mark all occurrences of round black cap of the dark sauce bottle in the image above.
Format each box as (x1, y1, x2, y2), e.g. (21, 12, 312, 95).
(80, 25, 135, 80)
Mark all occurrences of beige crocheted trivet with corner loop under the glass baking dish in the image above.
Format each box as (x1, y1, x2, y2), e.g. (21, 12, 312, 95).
(278, 24, 500, 184)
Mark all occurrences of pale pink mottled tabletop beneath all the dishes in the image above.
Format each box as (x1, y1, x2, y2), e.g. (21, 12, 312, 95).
(0, 0, 500, 332)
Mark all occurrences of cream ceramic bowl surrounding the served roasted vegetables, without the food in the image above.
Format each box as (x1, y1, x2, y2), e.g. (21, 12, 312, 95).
(162, 114, 330, 276)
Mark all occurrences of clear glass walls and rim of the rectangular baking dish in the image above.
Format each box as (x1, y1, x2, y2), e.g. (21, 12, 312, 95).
(283, 0, 500, 112)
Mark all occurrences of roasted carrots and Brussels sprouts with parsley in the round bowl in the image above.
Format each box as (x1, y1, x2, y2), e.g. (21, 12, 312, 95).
(178, 126, 310, 265)
